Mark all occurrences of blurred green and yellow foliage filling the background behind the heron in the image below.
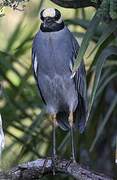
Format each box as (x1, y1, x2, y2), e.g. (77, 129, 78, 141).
(0, 0, 117, 180)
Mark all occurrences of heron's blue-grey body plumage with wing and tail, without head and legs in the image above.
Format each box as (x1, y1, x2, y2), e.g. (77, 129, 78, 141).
(32, 26, 87, 133)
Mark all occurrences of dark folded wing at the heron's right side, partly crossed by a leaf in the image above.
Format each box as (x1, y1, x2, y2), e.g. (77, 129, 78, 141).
(72, 37, 87, 133)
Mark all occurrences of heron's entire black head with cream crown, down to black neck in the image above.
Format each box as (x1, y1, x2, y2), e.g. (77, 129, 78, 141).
(40, 8, 64, 32)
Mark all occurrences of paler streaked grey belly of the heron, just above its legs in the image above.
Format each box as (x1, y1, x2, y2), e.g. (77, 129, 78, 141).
(39, 74, 77, 112)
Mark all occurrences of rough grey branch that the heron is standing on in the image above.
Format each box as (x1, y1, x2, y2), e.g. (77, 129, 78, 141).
(0, 158, 112, 180)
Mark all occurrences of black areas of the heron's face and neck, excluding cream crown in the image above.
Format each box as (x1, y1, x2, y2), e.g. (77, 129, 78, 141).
(40, 9, 64, 32)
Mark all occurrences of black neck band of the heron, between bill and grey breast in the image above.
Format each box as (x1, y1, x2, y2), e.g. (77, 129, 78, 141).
(40, 21, 65, 32)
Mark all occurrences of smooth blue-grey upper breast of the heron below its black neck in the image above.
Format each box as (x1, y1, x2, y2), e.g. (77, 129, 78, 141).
(38, 29, 72, 74)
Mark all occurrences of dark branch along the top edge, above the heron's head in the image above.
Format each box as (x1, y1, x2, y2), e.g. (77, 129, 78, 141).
(50, 0, 100, 9)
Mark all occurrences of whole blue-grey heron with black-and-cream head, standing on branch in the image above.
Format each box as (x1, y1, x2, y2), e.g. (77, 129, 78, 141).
(32, 8, 87, 166)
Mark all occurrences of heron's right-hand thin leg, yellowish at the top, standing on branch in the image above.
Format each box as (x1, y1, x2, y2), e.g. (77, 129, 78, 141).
(68, 112, 76, 162)
